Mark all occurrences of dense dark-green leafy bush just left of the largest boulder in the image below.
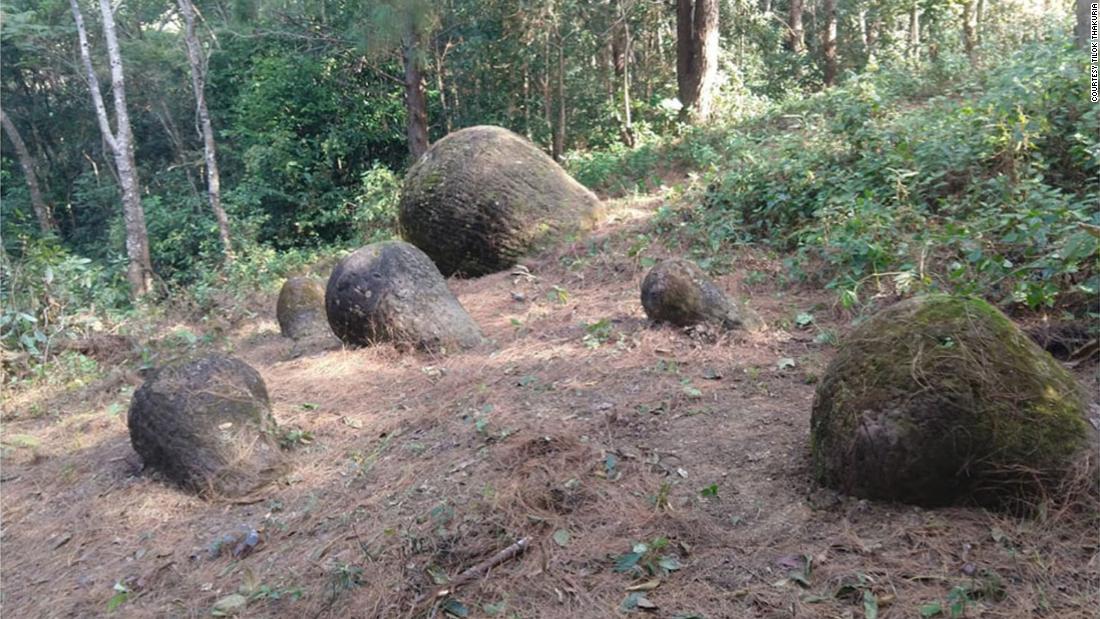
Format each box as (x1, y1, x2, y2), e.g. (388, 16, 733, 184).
(227, 51, 405, 247)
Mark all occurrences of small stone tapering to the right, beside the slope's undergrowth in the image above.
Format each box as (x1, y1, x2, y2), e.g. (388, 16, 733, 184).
(641, 258, 763, 331)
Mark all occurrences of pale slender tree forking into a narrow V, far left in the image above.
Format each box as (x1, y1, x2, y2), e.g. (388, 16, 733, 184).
(69, 0, 153, 298)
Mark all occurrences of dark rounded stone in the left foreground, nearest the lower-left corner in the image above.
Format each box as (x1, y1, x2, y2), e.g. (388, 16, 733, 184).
(129, 355, 284, 497)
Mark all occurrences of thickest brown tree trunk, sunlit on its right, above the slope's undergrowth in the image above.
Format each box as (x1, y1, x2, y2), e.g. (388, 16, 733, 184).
(677, 0, 718, 122)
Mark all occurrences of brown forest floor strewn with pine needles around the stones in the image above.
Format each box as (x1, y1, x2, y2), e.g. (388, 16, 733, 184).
(0, 198, 1100, 619)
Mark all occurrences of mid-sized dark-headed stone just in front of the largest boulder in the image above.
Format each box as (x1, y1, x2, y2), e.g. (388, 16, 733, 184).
(325, 241, 482, 352)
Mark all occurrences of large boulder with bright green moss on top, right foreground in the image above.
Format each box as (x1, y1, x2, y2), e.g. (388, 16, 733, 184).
(811, 295, 1088, 506)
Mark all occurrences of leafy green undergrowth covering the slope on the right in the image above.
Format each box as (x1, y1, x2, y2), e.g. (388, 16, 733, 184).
(572, 42, 1100, 314)
